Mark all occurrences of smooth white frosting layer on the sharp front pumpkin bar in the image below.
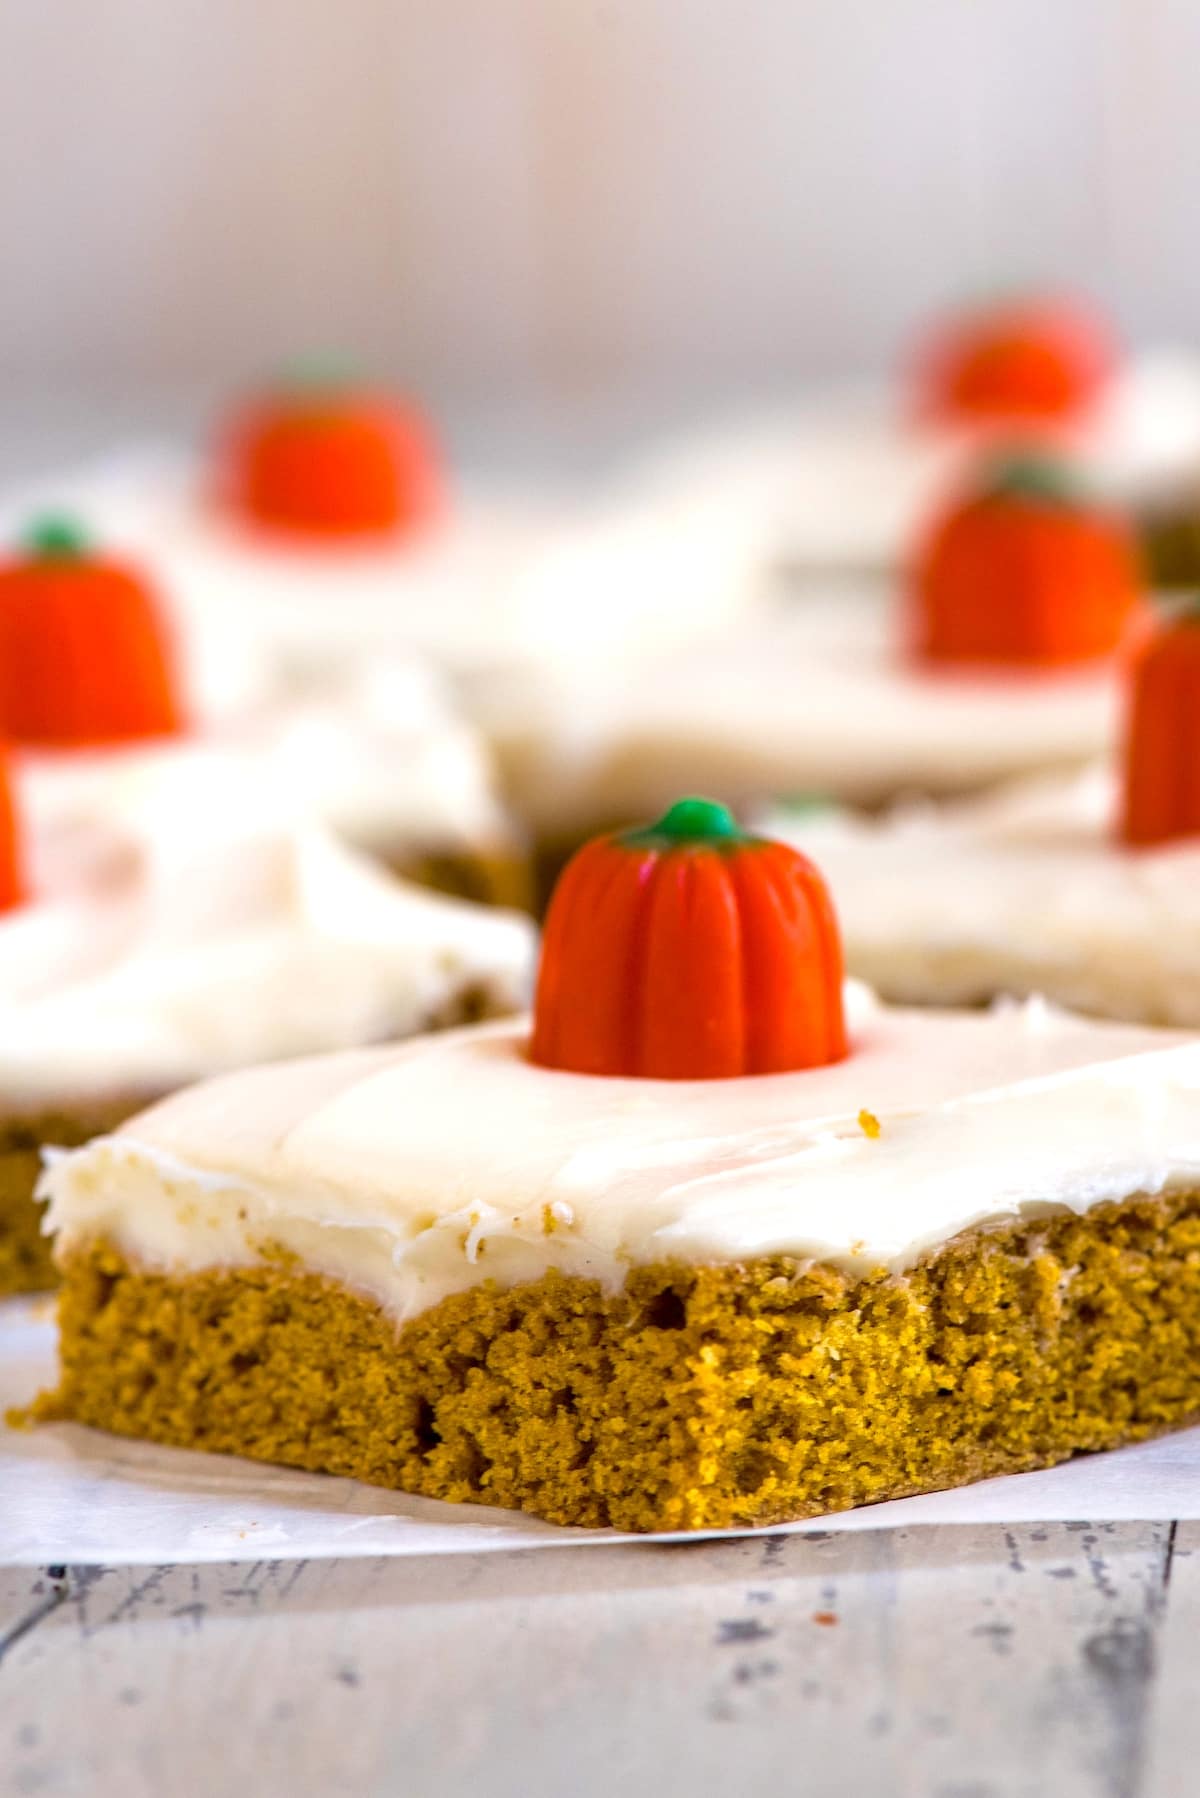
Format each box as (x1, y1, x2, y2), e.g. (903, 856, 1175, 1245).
(45, 991, 1200, 1318)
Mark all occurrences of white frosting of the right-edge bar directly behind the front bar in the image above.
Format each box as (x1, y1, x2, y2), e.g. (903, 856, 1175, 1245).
(756, 766, 1200, 1028)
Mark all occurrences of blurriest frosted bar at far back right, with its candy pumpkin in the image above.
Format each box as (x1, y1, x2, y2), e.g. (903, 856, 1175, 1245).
(633, 293, 1200, 575)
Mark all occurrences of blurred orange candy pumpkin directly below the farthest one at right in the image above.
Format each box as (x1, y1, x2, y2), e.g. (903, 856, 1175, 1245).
(910, 455, 1142, 667)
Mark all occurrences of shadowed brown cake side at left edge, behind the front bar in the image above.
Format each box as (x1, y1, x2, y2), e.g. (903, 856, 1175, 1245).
(0, 1095, 148, 1296)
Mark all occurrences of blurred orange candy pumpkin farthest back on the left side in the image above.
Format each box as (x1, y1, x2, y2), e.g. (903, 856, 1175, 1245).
(221, 364, 443, 538)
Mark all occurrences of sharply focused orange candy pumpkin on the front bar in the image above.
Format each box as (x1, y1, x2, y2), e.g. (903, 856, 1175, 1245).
(531, 798, 846, 1081)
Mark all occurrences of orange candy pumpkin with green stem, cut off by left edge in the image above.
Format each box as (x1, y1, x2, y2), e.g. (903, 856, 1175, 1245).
(0, 518, 184, 748)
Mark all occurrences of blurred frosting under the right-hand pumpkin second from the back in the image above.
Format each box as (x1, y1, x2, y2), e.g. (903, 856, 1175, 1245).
(477, 590, 1117, 831)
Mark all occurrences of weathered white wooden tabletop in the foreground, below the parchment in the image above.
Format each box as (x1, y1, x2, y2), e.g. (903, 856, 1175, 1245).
(0, 1523, 1200, 1798)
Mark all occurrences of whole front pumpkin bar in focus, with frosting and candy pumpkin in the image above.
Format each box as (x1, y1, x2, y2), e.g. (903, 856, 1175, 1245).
(34, 800, 1200, 1530)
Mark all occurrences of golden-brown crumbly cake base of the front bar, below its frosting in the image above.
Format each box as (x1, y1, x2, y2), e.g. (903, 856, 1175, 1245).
(32, 1192, 1200, 1530)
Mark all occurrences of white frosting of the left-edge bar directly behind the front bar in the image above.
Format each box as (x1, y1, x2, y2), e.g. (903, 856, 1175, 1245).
(0, 752, 534, 1108)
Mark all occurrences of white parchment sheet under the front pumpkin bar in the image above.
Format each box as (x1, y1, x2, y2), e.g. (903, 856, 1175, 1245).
(0, 1300, 1200, 1566)
